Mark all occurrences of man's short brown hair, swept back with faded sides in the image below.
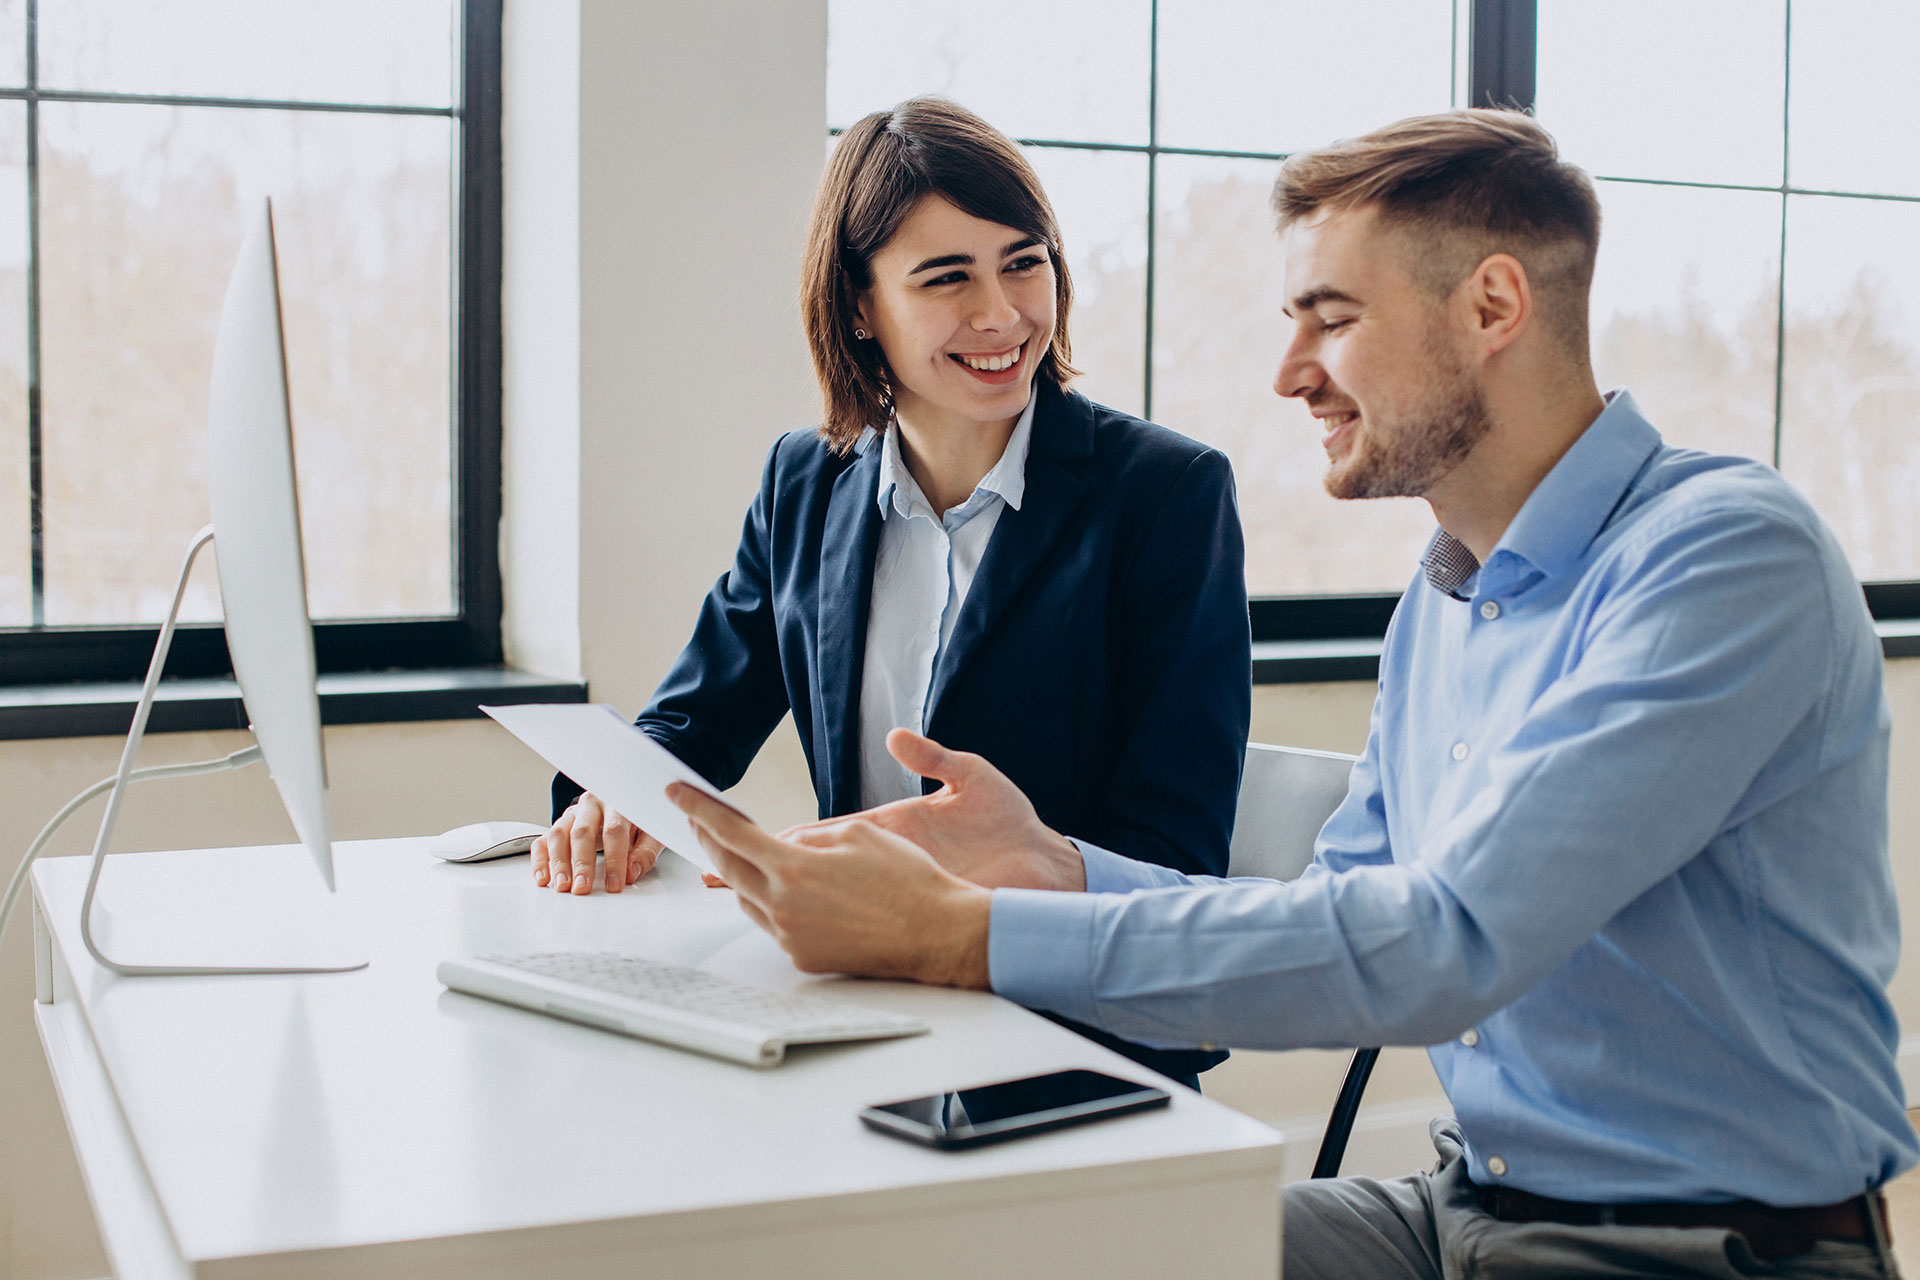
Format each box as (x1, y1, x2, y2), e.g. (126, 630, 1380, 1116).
(1273, 107, 1599, 359)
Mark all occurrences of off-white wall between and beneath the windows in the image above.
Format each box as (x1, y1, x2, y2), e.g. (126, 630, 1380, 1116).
(0, 0, 1920, 1280)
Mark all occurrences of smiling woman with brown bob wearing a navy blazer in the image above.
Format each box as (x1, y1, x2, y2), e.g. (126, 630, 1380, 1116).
(534, 98, 1250, 1075)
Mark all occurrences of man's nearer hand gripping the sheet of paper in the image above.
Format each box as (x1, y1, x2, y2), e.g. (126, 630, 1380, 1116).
(666, 783, 993, 990)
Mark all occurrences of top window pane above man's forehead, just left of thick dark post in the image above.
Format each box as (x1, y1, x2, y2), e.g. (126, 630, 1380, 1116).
(1160, 0, 1465, 152)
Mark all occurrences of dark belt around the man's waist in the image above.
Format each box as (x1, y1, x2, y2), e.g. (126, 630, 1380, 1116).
(1480, 1186, 1885, 1261)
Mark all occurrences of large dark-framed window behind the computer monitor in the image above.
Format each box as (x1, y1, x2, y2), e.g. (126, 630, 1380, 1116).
(0, 0, 499, 683)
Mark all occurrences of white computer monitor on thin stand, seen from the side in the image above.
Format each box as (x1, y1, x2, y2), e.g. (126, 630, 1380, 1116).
(81, 200, 367, 977)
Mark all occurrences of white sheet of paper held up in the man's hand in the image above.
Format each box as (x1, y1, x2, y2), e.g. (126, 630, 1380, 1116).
(480, 702, 739, 871)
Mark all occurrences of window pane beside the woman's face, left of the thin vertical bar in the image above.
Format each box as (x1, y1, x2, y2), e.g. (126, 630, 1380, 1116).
(1027, 146, 1146, 415)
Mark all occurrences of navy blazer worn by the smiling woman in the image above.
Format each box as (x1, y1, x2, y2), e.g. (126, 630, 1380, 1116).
(553, 382, 1252, 1075)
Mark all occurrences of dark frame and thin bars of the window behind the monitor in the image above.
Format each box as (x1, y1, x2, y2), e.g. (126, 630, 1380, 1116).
(0, 0, 503, 687)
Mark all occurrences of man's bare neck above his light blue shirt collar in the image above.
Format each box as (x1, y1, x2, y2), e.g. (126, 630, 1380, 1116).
(1425, 378, 1607, 564)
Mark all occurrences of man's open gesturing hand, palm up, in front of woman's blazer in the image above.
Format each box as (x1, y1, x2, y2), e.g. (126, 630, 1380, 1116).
(781, 729, 1087, 892)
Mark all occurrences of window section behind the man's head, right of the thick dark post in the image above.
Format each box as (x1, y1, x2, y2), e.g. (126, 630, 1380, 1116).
(1538, 0, 1920, 616)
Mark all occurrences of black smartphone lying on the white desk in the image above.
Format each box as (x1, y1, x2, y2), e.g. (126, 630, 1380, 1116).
(860, 1071, 1169, 1151)
